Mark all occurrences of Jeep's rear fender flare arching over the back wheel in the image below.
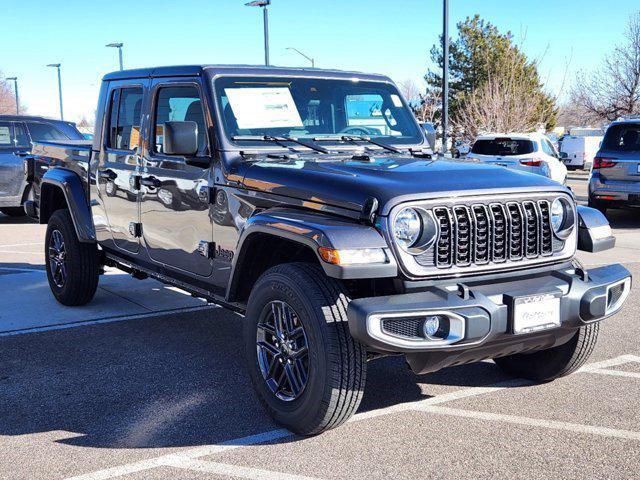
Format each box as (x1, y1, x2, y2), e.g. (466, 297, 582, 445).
(40, 168, 96, 243)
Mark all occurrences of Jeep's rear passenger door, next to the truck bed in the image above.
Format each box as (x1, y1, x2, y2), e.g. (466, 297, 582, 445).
(97, 83, 144, 253)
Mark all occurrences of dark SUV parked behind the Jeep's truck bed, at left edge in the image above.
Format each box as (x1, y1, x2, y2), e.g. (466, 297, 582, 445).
(0, 115, 83, 216)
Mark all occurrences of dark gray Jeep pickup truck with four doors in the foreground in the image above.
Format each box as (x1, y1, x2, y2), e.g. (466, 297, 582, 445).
(27, 66, 631, 434)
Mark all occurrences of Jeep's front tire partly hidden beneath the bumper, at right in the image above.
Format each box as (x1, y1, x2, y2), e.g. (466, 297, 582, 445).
(494, 323, 600, 382)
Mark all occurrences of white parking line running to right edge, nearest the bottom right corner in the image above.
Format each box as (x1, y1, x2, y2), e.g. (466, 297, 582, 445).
(419, 406, 640, 441)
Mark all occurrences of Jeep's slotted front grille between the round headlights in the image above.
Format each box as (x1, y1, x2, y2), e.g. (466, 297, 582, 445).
(424, 200, 554, 269)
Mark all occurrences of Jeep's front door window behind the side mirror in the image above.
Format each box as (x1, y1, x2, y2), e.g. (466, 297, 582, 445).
(154, 86, 207, 155)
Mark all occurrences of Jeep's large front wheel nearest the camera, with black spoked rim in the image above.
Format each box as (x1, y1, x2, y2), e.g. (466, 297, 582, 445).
(244, 263, 366, 435)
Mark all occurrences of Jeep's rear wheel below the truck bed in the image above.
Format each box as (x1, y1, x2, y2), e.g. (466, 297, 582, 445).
(44, 209, 99, 306)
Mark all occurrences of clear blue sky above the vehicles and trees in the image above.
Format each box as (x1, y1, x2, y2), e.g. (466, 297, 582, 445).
(0, 0, 640, 120)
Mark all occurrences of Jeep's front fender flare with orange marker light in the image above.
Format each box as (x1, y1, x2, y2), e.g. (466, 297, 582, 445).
(227, 209, 398, 298)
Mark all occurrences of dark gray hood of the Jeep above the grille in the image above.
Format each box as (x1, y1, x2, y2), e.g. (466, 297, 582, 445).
(243, 155, 564, 215)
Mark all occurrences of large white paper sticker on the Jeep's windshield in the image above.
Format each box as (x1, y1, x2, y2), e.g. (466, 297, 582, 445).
(225, 87, 303, 129)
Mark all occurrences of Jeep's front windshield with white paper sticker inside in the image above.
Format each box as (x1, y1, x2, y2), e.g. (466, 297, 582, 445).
(215, 77, 422, 145)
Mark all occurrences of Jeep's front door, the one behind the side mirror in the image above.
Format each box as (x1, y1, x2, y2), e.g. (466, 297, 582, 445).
(140, 78, 213, 277)
